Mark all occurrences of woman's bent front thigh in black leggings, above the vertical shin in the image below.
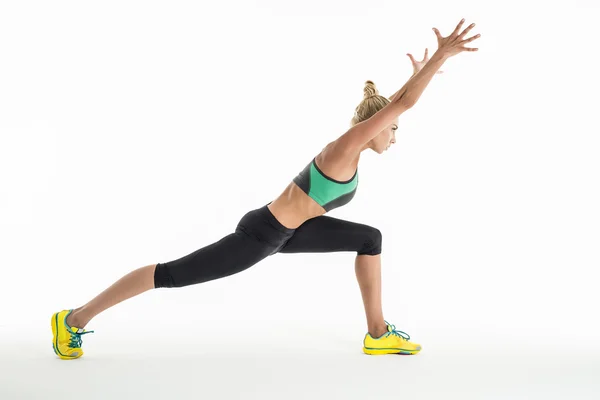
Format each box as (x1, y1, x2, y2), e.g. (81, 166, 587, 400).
(279, 215, 382, 255)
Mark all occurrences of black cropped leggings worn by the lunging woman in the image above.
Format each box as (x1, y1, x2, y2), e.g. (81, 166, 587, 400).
(154, 203, 381, 288)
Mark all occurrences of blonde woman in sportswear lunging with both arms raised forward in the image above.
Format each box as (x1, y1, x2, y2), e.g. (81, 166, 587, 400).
(51, 19, 480, 359)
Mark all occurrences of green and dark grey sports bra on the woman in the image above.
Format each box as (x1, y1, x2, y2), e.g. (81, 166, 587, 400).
(294, 157, 358, 211)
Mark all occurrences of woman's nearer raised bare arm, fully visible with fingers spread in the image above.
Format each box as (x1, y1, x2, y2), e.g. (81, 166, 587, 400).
(339, 19, 480, 151)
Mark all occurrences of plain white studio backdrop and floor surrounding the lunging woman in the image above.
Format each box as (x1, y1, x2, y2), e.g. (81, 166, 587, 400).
(0, 0, 600, 399)
